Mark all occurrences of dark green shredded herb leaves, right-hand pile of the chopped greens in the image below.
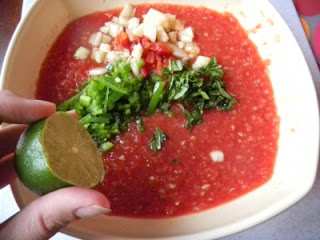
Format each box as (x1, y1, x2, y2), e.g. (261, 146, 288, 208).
(162, 58, 236, 128)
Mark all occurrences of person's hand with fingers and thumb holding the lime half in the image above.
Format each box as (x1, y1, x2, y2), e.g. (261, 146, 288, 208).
(0, 90, 110, 240)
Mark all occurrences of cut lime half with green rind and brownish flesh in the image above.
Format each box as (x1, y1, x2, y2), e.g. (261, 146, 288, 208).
(15, 112, 105, 195)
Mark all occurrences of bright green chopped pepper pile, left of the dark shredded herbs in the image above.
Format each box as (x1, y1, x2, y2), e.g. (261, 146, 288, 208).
(58, 61, 142, 152)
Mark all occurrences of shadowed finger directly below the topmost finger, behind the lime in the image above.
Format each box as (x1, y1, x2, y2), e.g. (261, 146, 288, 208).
(0, 124, 28, 159)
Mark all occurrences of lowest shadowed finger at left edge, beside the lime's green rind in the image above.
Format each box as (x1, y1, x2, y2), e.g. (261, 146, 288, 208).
(0, 153, 17, 189)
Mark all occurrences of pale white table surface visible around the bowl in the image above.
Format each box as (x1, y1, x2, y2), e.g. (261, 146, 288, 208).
(0, 0, 320, 240)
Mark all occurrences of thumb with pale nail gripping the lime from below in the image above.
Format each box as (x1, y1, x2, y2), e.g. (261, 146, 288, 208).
(0, 187, 110, 240)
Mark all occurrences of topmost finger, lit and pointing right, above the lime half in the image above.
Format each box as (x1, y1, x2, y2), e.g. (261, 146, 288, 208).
(0, 90, 56, 123)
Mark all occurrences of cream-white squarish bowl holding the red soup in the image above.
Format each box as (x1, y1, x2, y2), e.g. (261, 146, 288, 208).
(0, 0, 319, 239)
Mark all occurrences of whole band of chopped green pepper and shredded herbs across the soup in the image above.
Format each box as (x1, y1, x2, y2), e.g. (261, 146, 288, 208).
(58, 58, 236, 152)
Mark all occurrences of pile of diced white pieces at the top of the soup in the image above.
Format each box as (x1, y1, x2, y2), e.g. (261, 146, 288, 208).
(75, 4, 200, 69)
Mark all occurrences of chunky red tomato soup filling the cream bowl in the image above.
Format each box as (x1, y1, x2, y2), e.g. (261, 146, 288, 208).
(36, 4, 279, 218)
